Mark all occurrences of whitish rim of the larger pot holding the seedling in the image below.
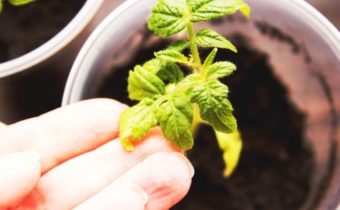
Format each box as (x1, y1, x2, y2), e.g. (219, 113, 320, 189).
(62, 0, 340, 106)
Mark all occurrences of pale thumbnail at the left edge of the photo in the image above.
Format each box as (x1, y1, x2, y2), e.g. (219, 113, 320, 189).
(0, 151, 40, 169)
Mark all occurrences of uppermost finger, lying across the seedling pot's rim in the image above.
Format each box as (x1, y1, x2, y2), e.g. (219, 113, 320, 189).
(0, 99, 126, 173)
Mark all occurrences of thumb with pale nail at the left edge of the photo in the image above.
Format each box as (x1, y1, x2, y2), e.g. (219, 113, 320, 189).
(0, 152, 41, 209)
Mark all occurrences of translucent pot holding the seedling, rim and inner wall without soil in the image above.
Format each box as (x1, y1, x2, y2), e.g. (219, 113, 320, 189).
(63, 0, 340, 210)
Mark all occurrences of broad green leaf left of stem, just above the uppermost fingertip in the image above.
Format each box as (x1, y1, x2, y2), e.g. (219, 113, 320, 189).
(128, 65, 165, 100)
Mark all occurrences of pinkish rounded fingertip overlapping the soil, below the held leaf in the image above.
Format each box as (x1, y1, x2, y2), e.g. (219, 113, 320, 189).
(116, 153, 194, 210)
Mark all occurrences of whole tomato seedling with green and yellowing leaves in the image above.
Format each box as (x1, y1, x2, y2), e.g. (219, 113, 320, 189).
(120, 0, 250, 176)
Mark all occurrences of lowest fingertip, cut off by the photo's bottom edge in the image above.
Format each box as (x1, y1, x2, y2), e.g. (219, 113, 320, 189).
(74, 183, 148, 210)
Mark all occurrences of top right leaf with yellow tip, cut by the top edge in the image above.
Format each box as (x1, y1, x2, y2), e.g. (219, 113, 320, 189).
(189, 0, 248, 22)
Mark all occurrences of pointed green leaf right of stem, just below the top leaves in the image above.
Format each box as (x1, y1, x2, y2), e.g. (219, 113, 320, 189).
(195, 28, 237, 52)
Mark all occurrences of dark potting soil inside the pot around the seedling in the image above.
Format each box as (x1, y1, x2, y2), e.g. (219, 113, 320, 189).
(96, 31, 314, 210)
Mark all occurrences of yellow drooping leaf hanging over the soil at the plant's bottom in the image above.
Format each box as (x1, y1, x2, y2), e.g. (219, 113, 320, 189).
(215, 130, 242, 177)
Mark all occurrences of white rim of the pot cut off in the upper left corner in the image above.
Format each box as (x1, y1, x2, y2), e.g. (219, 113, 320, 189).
(0, 0, 103, 78)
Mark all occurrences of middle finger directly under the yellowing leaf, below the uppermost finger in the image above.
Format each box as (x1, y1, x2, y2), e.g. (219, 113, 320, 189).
(20, 129, 183, 209)
